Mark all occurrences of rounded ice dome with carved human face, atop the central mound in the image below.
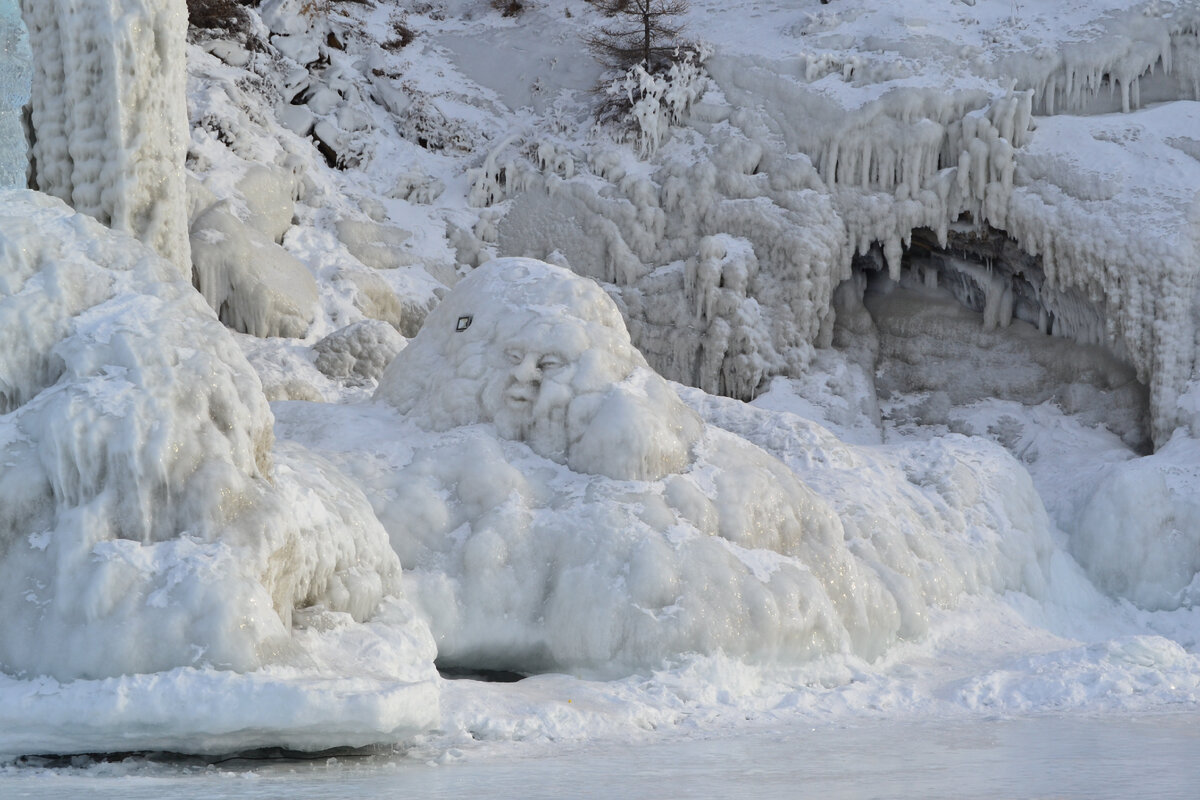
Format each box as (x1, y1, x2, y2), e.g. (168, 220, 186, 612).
(376, 258, 700, 480)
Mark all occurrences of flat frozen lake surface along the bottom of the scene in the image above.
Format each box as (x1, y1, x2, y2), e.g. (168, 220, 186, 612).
(0, 712, 1200, 800)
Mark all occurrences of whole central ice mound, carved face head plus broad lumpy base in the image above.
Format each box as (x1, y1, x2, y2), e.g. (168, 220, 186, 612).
(276, 259, 1050, 675)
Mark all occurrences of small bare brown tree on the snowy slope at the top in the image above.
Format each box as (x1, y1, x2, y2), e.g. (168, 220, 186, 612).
(584, 0, 688, 72)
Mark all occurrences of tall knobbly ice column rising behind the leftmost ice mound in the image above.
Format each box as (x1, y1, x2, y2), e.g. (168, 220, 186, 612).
(20, 0, 191, 275)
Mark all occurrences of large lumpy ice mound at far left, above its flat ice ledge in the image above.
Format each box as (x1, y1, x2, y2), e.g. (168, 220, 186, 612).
(0, 192, 436, 746)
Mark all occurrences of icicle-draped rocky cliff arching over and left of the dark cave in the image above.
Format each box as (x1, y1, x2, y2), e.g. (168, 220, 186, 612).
(485, 2, 1200, 455)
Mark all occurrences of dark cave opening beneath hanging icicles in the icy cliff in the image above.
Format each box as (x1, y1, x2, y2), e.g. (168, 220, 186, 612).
(849, 224, 1153, 457)
